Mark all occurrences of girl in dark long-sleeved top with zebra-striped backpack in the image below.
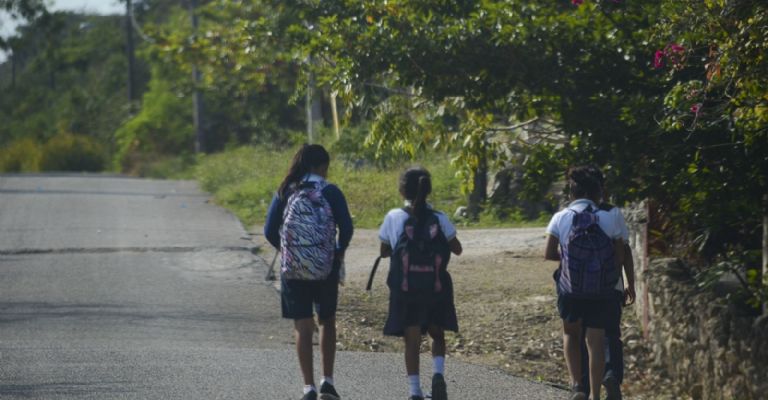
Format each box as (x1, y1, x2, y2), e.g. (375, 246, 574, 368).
(264, 145, 353, 400)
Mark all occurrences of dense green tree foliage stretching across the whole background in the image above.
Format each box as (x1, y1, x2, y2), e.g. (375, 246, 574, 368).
(0, 0, 768, 296)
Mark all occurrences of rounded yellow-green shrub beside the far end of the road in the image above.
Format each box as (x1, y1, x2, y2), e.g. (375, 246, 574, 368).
(40, 133, 107, 172)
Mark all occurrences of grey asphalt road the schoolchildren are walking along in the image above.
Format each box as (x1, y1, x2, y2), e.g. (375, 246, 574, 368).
(0, 175, 565, 400)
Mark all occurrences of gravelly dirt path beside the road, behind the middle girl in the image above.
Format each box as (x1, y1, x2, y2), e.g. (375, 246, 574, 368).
(252, 227, 656, 399)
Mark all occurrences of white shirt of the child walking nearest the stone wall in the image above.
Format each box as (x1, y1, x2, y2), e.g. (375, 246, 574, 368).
(547, 199, 629, 291)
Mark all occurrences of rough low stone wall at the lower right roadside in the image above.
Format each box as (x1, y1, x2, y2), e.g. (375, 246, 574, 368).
(638, 259, 768, 400)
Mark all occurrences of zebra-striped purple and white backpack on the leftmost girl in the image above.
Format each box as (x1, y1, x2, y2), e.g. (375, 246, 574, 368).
(280, 181, 336, 280)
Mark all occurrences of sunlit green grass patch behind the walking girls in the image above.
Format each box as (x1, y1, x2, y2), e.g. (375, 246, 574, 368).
(184, 146, 549, 228)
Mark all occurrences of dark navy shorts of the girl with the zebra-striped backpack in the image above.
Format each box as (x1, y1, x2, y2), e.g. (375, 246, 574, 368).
(280, 276, 339, 320)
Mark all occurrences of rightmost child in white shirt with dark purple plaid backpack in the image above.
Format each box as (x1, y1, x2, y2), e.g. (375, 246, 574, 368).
(544, 166, 626, 400)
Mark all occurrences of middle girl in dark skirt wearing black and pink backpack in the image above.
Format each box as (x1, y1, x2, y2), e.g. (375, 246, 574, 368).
(379, 167, 462, 400)
